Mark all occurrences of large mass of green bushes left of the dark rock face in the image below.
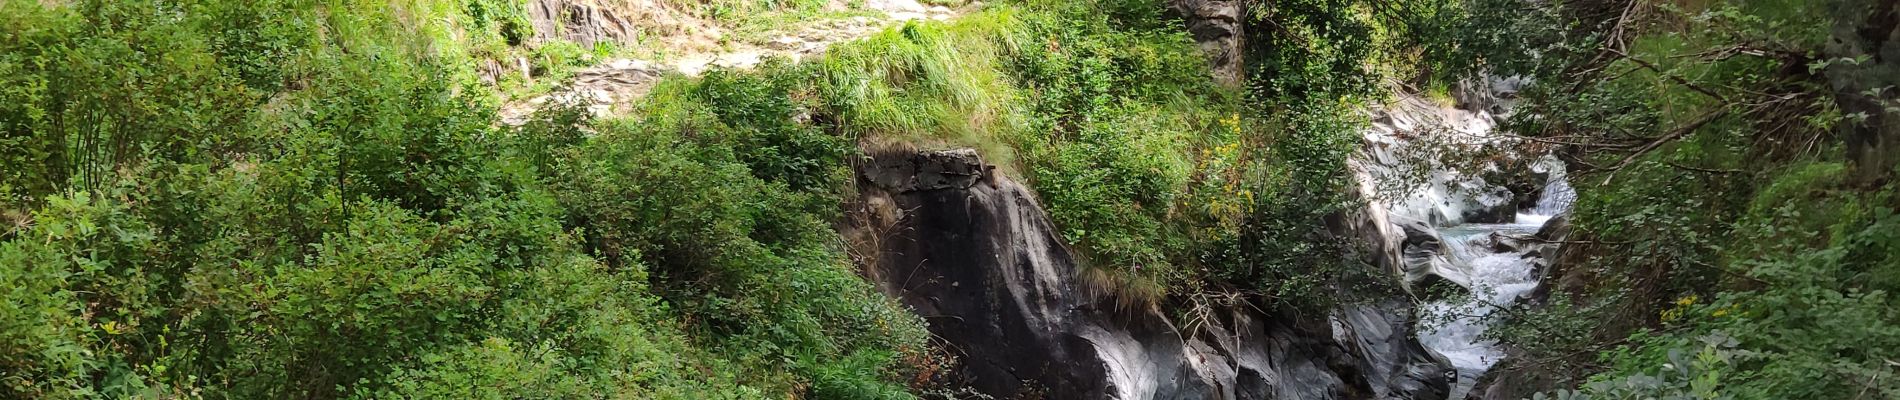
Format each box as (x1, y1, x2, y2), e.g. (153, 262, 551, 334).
(0, 0, 923, 398)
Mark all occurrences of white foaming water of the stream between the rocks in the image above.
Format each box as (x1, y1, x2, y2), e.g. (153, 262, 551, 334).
(1419, 174, 1575, 398)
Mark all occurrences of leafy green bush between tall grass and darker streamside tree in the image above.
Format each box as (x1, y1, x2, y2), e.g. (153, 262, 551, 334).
(1013, 2, 1241, 303)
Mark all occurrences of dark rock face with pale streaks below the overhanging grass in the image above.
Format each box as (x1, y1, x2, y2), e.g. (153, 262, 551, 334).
(842, 150, 1448, 400)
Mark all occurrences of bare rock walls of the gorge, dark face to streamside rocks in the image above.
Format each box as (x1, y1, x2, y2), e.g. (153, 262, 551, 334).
(844, 83, 1566, 398)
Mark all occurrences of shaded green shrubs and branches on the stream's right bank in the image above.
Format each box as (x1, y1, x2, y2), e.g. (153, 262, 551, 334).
(1436, 0, 1900, 398)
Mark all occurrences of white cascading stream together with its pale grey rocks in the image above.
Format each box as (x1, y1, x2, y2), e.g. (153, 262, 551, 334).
(1353, 85, 1575, 398)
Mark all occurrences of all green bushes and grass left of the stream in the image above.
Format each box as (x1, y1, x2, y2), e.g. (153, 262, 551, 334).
(0, 0, 1428, 398)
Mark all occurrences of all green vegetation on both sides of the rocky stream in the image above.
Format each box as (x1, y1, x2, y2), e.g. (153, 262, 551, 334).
(14, 0, 1900, 398)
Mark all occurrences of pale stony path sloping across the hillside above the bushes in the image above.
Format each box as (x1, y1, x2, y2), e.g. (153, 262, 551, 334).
(500, 0, 965, 125)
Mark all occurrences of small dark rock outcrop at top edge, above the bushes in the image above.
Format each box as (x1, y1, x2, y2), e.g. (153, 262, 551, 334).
(1169, 0, 1246, 87)
